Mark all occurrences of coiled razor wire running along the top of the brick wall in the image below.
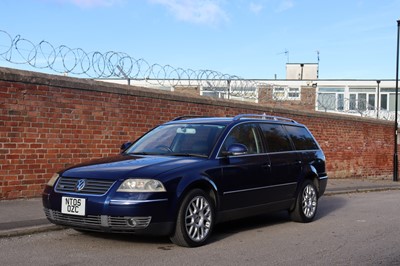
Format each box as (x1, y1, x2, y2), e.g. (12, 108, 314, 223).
(0, 29, 394, 120)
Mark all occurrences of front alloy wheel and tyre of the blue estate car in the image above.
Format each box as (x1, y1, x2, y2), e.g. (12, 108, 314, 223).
(171, 189, 215, 247)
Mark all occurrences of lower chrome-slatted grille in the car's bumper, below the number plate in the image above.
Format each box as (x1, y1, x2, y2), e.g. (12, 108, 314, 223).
(44, 208, 151, 232)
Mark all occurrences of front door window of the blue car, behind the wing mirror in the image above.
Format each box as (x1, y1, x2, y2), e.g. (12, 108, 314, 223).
(222, 124, 262, 154)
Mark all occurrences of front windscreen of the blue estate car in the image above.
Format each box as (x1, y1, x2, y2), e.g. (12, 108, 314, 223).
(125, 124, 225, 157)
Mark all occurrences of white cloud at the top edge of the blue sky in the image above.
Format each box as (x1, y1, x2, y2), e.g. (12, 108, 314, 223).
(150, 0, 229, 26)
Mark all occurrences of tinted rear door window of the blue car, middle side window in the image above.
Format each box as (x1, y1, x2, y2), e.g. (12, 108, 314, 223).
(260, 124, 292, 152)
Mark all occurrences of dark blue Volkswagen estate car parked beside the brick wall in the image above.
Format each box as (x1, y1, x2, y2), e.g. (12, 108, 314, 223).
(43, 114, 328, 247)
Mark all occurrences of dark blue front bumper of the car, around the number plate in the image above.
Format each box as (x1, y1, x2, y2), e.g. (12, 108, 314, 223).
(42, 187, 175, 235)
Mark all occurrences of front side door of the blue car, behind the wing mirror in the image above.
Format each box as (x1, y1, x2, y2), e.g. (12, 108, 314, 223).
(216, 123, 270, 211)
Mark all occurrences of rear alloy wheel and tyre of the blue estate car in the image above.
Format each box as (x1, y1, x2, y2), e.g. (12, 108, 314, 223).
(290, 180, 318, 223)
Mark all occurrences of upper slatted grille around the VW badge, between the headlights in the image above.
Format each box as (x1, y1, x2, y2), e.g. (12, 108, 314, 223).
(56, 177, 115, 195)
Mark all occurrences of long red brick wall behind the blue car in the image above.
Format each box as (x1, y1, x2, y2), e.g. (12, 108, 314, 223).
(0, 68, 393, 199)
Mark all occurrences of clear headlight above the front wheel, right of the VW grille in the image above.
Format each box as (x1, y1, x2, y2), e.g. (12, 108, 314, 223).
(117, 178, 166, 192)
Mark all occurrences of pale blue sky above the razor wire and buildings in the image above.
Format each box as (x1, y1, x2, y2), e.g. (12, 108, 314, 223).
(0, 0, 400, 79)
